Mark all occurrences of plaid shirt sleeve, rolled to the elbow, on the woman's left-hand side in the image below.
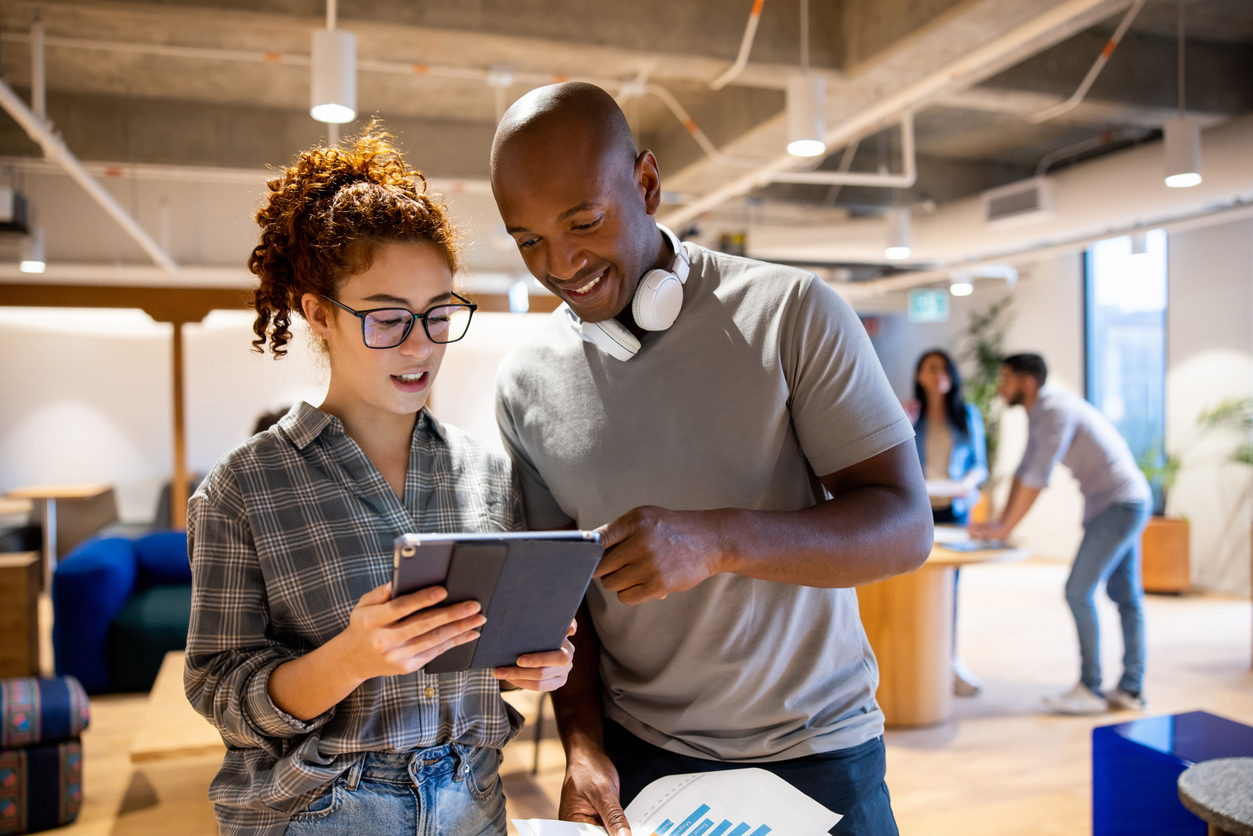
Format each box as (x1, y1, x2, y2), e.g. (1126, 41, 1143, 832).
(183, 470, 335, 757)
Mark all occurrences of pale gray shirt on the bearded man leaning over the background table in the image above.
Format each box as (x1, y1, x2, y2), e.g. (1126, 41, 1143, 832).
(1015, 386, 1153, 523)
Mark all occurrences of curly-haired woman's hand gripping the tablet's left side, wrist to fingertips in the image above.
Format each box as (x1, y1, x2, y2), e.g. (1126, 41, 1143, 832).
(340, 583, 487, 682)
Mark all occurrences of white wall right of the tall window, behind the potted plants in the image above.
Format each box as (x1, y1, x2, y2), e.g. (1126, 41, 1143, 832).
(1167, 221, 1253, 594)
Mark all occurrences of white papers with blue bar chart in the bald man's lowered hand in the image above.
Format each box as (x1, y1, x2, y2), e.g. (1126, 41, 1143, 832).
(514, 768, 841, 836)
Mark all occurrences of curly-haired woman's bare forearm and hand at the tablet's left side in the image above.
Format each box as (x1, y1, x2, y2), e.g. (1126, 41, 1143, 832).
(266, 583, 487, 721)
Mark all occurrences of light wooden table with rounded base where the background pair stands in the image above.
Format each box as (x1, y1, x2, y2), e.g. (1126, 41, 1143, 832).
(857, 526, 1026, 727)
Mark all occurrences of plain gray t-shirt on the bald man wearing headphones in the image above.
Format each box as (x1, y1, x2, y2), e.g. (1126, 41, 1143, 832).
(496, 244, 913, 762)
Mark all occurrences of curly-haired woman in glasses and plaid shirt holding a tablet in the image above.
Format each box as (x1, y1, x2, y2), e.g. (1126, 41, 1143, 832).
(184, 125, 574, 835)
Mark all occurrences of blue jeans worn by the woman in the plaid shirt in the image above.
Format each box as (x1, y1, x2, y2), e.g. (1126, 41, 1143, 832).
(287, 743, 505, 836)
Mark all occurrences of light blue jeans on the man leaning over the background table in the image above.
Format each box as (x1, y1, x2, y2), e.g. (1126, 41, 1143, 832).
(1066, 503, 1150, 694)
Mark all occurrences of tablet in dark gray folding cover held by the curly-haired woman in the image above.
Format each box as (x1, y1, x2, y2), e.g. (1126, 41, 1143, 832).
(392, 531, 604, 673)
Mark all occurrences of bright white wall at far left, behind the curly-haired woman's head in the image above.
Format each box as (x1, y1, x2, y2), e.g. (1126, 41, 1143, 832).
(0, 308, 325, 521)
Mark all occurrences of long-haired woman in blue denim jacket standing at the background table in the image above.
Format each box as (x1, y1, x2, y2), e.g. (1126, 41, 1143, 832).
(913, 348, 987, 697)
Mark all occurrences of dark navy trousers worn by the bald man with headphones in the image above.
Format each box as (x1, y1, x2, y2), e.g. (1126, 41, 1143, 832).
(605, 719, 897, 836)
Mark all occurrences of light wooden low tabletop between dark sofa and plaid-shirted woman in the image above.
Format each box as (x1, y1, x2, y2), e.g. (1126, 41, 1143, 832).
(130, 651, 227, 763)
